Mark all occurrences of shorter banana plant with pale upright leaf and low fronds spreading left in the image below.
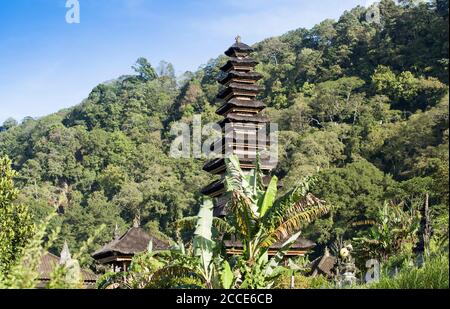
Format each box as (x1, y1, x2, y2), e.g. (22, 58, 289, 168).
(99, 199, 236, 289)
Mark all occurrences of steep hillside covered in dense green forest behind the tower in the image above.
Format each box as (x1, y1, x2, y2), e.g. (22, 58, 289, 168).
(0, 0, 449, 264)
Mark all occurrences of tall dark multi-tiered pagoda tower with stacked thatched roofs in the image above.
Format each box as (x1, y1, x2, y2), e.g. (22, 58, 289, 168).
(202, 37, 275, 217)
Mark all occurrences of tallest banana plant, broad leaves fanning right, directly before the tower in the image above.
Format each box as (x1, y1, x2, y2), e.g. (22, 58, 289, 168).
(225, 155, 329, 288)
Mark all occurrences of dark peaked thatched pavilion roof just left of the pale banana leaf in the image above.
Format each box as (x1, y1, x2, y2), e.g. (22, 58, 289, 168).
(92, 227, 170, 260)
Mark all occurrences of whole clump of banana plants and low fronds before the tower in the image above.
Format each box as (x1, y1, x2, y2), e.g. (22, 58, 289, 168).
(99, 156, 328, 289)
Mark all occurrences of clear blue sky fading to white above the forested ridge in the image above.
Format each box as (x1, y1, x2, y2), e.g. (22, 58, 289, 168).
(0, 0, 372, 124)
